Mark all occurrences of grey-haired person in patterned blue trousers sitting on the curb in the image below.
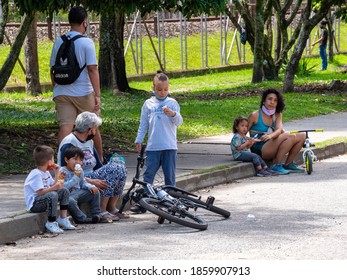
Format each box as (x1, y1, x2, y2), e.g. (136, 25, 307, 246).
(58, 112, 129, 221)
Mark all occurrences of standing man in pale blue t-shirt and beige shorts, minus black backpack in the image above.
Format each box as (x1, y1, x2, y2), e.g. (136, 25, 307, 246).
(50, 6, 103, 160)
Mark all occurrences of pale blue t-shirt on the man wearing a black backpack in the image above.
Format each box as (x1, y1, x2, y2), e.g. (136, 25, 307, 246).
(49, 31, 97, 98)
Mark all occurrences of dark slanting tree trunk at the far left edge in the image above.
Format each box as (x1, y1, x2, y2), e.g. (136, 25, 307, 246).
(0, 15, 34, 90)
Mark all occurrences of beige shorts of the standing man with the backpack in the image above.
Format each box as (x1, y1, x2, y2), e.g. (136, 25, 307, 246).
(53, 92, 100, 126)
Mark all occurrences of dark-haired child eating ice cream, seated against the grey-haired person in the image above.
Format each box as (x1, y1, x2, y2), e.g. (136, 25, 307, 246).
(60, 146, 100, 224)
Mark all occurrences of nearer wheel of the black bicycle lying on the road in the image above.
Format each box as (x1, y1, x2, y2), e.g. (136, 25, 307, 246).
(139, 197, 207, 230)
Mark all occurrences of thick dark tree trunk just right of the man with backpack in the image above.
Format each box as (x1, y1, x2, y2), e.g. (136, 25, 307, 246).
(99, 13, 130, 91)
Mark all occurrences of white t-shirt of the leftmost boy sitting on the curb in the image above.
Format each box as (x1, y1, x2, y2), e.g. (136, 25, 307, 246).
(24, 168, 54, 210)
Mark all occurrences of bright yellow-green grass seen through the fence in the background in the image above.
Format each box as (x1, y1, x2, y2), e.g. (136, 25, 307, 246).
(0, 20, 347, 86)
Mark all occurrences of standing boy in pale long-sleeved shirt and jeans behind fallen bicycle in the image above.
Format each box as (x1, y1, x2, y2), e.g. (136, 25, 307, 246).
(131, 72, 183, 212)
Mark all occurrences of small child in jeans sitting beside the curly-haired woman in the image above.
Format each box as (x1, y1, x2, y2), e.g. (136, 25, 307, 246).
(230, 117, 275, 177)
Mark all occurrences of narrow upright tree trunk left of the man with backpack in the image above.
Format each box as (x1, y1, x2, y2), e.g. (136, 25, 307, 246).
(24, 16, 42, 95)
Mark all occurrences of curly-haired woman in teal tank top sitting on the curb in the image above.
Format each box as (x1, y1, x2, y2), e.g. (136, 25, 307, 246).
(248, 89, 305, 175)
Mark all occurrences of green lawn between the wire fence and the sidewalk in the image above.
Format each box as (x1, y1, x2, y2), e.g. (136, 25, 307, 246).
(0, 68, 347, 144)
